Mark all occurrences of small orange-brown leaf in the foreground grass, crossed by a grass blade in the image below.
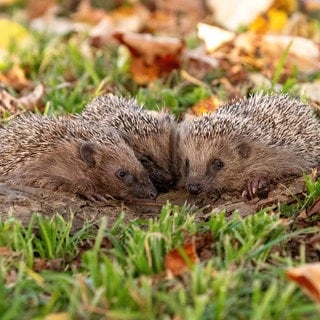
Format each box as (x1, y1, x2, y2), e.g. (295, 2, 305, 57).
(164, 238, 199, 276)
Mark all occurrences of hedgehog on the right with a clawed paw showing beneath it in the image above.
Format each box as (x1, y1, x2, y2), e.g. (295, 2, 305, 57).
(177, 94, 320, 198)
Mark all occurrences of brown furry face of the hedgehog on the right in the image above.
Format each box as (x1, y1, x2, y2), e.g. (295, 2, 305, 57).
(179, 136, 250, 195)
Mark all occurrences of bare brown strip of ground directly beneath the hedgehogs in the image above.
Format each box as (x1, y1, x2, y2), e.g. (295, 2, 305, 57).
(0, 178, 305, 230)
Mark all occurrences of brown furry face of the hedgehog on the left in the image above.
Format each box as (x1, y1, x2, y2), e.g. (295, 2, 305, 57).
(80, 143, 157, 200)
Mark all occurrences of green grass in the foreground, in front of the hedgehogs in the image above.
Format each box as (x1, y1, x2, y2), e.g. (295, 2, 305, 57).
(0, 204, 319, 319)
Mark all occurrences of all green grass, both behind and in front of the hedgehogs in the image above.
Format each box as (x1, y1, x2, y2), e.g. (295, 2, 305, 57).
(0, 4, 320, 320)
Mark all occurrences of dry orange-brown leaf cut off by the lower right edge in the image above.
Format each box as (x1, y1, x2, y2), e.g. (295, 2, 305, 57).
(287, 263, 320, 303)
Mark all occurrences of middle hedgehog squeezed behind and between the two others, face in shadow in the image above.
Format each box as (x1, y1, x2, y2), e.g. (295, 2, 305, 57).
(80, 94, 176, 191)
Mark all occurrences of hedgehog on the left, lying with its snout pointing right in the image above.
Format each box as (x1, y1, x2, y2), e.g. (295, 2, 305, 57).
(0, 114, 157, 201)
